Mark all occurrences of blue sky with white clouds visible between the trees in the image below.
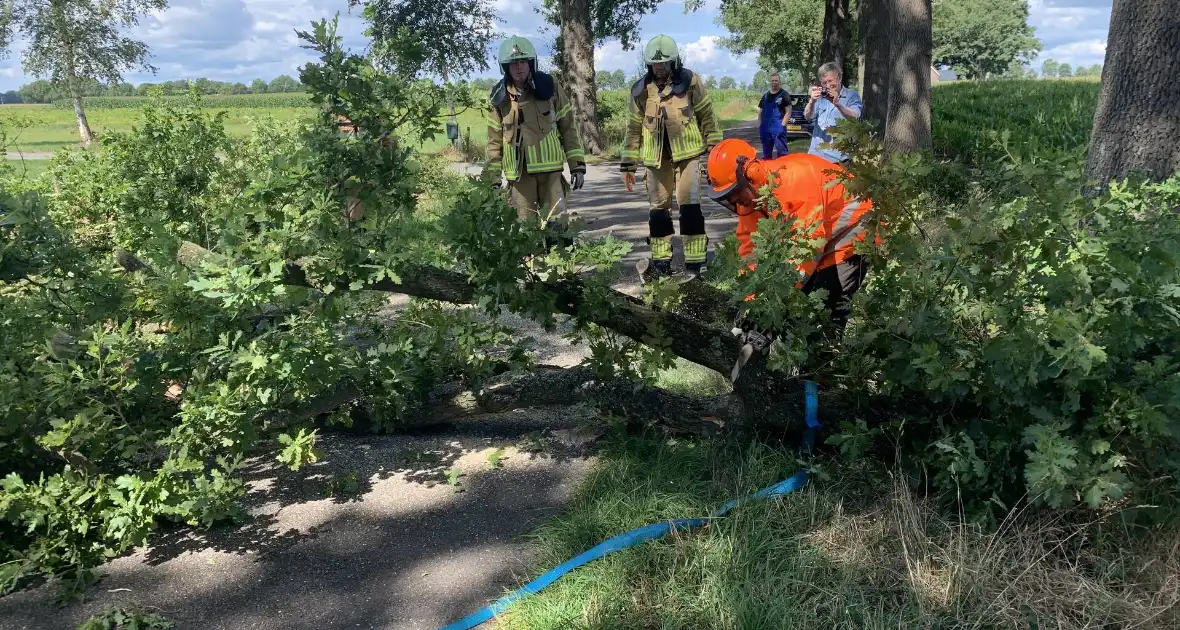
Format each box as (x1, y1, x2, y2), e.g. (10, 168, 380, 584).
(0, 0, 1112, 91)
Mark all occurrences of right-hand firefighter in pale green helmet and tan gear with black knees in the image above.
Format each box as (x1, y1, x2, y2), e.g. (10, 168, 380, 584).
(622, 35, 722, 277)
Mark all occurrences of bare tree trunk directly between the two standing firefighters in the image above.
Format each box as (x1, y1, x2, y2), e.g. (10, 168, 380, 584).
(558, 0, 603, 156)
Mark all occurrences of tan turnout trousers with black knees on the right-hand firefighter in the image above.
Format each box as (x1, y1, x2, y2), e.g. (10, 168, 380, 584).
(645, 157, 709, 267)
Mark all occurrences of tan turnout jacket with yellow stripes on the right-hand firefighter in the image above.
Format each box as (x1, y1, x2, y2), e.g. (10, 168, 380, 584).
(621, 68, 722, 171)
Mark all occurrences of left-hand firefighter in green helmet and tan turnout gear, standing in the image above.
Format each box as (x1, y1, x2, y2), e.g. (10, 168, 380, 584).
(484, 37, 586, 223)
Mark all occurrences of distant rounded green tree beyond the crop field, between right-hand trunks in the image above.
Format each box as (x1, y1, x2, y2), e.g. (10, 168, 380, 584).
(933, 0, 1042, 79)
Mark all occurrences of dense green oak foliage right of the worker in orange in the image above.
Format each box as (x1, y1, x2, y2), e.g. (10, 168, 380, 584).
(816, 126, 1180, 516)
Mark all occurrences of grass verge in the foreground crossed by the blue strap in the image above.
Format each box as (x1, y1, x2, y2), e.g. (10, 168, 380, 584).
(498, 437, 1180, 630)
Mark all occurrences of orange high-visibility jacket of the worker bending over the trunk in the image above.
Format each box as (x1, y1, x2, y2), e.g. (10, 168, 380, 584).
(736, 153, 880, 275)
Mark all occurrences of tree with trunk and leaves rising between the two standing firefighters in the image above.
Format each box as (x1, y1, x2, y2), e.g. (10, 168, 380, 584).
(544, 0, 660, 155)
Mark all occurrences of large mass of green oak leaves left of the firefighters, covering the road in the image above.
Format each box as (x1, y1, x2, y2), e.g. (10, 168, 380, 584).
(0, 22, 524, 592)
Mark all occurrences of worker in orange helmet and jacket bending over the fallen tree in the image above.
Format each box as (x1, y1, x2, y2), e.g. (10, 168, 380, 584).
(708, 138, 879, 378)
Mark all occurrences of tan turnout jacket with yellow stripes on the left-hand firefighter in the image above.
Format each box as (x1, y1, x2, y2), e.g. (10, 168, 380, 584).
(486, 72, 585, 182)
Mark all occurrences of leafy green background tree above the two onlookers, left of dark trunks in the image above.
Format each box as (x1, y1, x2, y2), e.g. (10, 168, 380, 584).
(719, 0, 826, 81)
